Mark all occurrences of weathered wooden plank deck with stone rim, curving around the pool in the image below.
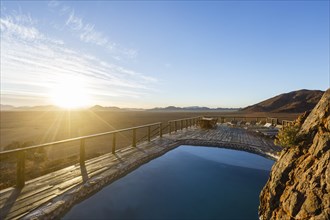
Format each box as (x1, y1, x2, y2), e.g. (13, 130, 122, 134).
(0, 125, 281, 219)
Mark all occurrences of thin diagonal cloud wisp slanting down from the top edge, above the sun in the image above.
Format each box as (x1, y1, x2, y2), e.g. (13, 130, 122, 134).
(48, 1, 138, 60)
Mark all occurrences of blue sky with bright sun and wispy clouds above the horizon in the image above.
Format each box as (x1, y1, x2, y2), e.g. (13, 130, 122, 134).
(0, 0, 330, 108)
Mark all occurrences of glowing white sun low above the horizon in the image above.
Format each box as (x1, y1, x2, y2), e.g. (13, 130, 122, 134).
(50, 77, 90, 109)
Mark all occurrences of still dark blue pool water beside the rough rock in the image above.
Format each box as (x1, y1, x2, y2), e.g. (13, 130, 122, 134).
(64, 146, 274, 220)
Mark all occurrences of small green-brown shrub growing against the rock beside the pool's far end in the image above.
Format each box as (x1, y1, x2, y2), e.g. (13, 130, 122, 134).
(275, 125, 300, 148)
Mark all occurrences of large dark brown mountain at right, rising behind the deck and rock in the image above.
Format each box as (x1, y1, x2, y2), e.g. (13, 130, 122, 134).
(242, 89, 324, 113)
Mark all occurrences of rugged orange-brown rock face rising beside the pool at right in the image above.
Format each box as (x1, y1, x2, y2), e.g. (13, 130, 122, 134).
(259, 89, 330, 219)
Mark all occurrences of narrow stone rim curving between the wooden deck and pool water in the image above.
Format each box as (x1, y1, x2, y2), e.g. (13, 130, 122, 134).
(23, 139, 278, 219)
